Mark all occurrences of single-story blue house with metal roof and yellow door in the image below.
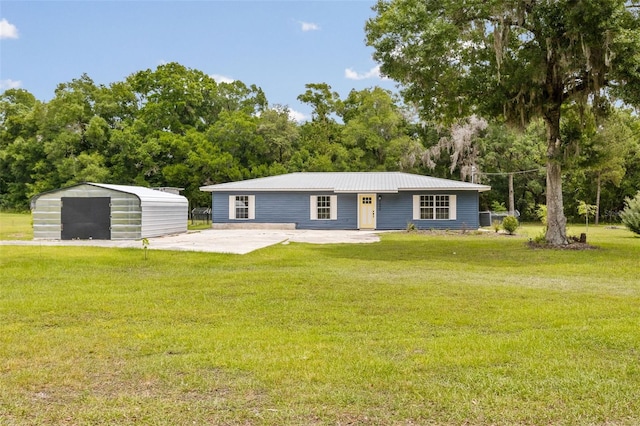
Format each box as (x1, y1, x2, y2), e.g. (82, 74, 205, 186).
(200, 172, 490, 230)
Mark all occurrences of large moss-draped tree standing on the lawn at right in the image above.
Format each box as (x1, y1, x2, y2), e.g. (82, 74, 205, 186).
(366, 0, 640, 245)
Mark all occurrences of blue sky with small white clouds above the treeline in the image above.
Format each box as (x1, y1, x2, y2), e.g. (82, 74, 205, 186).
(0, 0, 395, 119)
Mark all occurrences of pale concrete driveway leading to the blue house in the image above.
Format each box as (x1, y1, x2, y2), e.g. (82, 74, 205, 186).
(0, 229, 380, 254)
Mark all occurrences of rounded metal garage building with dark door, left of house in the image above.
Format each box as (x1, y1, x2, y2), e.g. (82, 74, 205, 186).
(31, 183, 189, 240)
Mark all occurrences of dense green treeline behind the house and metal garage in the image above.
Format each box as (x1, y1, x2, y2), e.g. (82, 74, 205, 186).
(0, 63, 640, 223)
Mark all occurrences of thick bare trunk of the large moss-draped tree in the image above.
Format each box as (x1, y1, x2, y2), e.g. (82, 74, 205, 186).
(544, 104, 569, 246)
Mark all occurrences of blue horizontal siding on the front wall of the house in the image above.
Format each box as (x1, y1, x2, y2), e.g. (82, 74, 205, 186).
(212, 191, 478, 230)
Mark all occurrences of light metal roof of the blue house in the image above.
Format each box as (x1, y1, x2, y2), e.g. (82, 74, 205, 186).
(200, 172, 491, 193)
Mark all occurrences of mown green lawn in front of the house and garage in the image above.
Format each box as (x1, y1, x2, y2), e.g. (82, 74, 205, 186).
(0, 215, 640, 425)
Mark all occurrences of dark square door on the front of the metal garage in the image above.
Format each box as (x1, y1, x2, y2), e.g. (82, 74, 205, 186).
(60, 197, 111, 240)
